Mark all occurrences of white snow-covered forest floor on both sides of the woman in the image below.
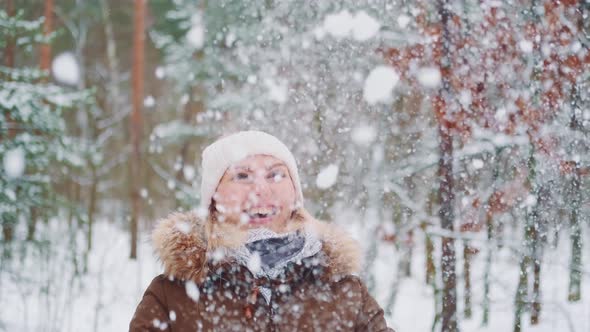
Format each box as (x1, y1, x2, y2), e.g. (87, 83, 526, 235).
(0, 221, 590, 332)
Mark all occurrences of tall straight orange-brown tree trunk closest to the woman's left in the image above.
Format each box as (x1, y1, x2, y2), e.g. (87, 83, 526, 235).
(129, 0, 146, 259)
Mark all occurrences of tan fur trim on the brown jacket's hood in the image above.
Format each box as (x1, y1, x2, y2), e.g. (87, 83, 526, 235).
(152, 209, 361, 283)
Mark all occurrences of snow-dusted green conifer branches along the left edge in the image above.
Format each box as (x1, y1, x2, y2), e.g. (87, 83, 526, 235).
(0, 7, 89, 257)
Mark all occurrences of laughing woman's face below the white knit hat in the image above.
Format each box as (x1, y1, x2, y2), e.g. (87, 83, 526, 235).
(213, 155, 296, 232)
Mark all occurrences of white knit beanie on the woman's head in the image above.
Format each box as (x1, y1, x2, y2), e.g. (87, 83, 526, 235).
(200, 130, 303, 210)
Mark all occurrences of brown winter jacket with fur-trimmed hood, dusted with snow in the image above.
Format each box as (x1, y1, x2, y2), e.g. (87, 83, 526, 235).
(129, 211, 393, 332)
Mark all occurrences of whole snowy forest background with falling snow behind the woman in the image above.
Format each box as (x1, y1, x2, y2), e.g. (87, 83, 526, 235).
(0, 0, 590, 332)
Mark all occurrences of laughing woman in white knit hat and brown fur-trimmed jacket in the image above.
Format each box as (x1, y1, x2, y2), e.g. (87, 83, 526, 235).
(130, 131, 392, 331)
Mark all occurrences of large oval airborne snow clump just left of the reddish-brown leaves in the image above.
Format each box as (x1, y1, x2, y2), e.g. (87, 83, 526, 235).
(363, 66, 399, 105)
